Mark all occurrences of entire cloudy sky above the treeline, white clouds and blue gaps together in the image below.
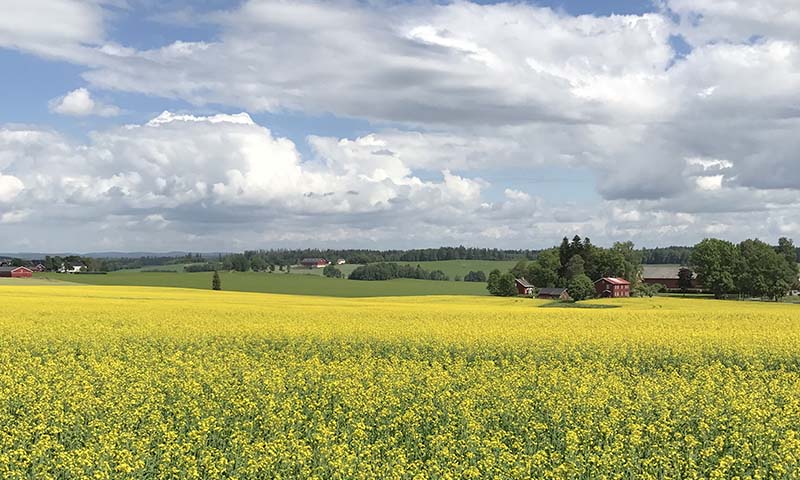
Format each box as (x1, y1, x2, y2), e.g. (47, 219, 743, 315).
(0, 0, 800, 251)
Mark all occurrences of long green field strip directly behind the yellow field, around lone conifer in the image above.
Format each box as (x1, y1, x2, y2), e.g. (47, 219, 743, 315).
(34, 271, 488, 297)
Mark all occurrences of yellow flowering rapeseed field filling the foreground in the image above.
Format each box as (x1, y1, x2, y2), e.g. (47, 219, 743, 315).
(0, 286, 800, 480)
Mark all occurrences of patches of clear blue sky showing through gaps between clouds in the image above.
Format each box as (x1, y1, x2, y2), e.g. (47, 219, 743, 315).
(0, 0, 655, 201)
